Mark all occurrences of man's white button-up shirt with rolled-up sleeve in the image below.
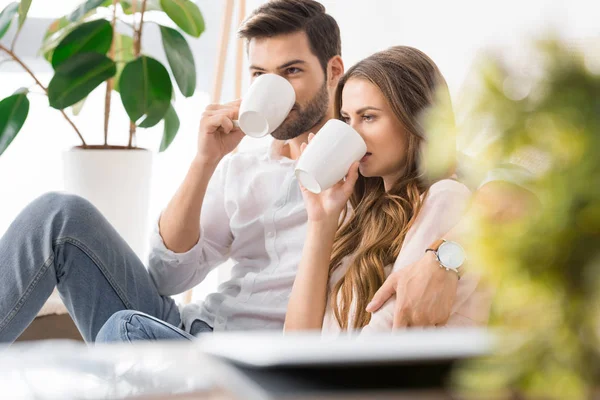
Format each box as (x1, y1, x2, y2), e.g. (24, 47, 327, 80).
(149, 141, 307, 331)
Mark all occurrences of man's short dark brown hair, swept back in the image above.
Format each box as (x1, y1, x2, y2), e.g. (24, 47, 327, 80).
(238, 0, 342, 72)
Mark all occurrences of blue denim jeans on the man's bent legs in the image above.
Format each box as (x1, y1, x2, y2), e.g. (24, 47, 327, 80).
(0, 193, 211, 343)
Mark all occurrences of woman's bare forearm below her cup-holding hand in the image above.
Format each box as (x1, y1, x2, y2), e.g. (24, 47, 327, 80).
(284, 220, 337, 331)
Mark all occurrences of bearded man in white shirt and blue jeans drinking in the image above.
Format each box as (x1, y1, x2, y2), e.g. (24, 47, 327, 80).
(0, 0, 528, 342)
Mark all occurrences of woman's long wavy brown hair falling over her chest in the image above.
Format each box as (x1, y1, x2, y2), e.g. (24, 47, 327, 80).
(329, 46, 447, 329)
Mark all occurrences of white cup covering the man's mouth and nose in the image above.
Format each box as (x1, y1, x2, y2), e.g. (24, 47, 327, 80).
(234, 74, 296, 138)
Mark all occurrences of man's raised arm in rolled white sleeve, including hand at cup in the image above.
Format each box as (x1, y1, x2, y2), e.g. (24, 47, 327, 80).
(148, 102, 243, 296)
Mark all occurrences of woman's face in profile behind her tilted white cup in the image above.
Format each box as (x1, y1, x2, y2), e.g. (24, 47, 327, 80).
(340, 78, 408, 190)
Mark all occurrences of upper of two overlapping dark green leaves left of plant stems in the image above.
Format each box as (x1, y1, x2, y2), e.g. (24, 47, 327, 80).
(52, 19, 113, 69)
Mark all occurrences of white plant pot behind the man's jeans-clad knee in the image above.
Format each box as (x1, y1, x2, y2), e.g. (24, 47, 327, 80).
(63, 148, 152, 259)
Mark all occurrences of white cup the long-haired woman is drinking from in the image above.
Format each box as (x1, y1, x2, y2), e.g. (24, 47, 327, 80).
(295, 119, 367, 193)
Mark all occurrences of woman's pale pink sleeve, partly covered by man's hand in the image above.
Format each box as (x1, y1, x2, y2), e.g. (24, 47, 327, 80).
(361, 179, 471, 335)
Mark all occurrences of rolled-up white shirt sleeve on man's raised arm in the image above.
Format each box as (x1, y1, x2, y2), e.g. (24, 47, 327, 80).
(148, 157, 233, 296)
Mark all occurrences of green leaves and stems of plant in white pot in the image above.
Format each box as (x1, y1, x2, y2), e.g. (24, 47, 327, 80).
(0, 0, 205, 155)
